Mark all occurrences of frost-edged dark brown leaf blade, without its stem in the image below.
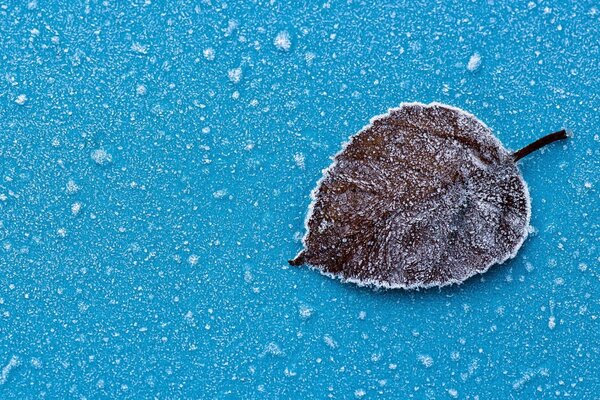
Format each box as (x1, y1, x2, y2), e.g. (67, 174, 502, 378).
(290, 103, 530, 288)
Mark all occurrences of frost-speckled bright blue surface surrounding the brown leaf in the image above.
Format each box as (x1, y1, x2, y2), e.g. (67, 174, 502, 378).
(0, 0, 600, 399)
